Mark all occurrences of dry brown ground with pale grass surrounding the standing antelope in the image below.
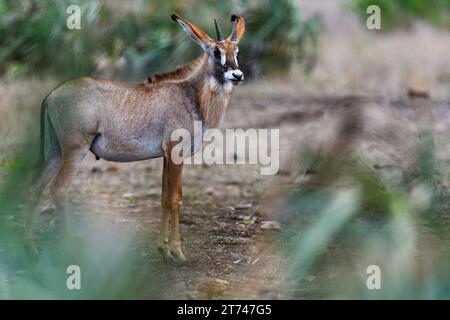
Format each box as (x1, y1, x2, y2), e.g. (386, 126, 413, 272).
(0, 1, 450, 299)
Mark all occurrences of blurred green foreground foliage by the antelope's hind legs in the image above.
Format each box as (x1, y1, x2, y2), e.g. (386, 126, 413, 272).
(0, 120, 155, 300)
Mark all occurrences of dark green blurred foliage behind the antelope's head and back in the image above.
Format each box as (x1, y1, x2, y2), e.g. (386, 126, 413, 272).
(0, 0, 319, 80)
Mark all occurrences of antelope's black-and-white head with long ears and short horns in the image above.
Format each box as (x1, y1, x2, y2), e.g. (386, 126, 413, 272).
(171, 13, 245, 85)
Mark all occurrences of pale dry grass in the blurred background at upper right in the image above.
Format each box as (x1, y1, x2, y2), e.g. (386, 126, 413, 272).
(282, 0, 450, 99)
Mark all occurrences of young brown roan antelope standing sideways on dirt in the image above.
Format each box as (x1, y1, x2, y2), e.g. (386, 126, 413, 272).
(25, 13, 245, 264)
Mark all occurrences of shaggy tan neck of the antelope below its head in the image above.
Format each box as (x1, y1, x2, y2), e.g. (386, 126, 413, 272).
(192, 58, 233, 128)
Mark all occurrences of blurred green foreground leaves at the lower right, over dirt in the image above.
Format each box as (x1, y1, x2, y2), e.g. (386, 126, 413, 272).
(283, 130, 450, 299)
